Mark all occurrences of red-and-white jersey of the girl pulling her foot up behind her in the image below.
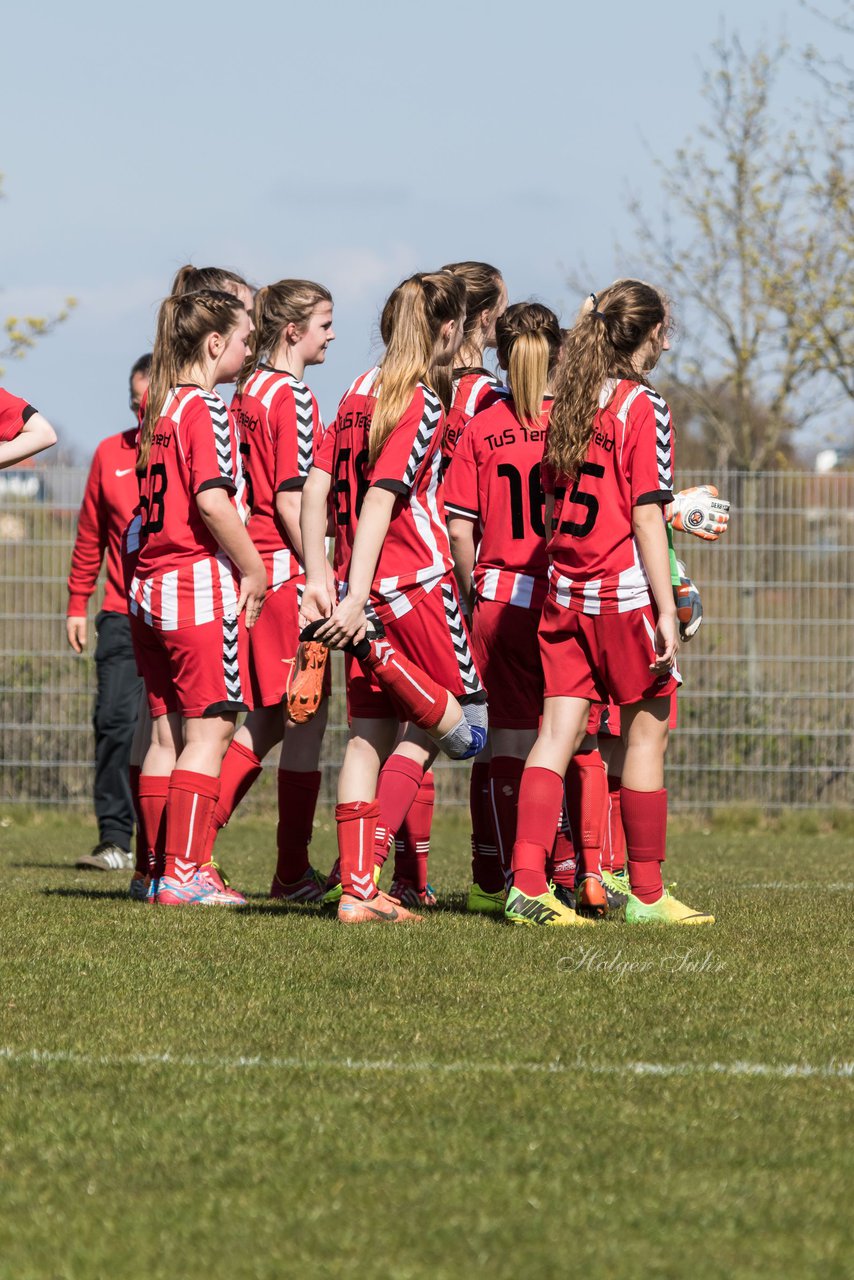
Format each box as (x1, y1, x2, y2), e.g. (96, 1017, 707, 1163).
(315, 369, 451, 617)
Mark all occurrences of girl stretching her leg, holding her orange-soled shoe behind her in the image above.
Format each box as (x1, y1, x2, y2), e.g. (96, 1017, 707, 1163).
(301, 271, 487, 923)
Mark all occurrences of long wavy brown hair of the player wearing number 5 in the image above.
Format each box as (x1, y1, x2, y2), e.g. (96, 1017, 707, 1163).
(545, 280, 667, 476)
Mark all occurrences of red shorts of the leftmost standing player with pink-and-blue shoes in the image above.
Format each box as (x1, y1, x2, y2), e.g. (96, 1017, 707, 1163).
(132, 613, 251, 719)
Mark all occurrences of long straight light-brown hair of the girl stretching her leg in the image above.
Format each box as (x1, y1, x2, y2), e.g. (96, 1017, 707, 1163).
(367, 271, 466, 462)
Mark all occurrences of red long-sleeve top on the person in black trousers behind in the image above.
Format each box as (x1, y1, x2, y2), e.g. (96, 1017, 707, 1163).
(68, 428, 140, 618)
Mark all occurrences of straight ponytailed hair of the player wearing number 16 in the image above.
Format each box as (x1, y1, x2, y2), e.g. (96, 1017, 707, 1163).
(495, 302, 562, 426)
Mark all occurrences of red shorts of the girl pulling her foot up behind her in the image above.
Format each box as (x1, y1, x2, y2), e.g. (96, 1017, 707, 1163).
(344, 573, 483, 721)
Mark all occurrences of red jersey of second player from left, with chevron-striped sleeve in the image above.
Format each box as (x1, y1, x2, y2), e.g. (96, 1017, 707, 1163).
(232, 365, 323, 590)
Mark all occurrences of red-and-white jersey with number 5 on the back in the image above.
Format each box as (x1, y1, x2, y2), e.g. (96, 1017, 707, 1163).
(543, 380, 673, 613)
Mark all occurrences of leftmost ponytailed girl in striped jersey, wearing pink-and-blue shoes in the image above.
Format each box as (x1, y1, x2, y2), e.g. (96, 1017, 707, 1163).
(128, 289, 266, 906)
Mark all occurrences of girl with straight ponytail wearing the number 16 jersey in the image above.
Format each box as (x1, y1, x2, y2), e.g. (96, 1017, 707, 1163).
(444, 302, 561, 914)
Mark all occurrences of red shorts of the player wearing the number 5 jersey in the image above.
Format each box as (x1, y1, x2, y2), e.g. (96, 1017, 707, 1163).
(539, 596, 679, 705)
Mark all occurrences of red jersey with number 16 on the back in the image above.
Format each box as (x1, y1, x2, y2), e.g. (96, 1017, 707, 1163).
(444, 397, 552, 608)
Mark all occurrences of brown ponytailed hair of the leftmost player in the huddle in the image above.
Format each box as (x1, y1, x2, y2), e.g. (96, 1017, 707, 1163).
(137, 289, 246, 471)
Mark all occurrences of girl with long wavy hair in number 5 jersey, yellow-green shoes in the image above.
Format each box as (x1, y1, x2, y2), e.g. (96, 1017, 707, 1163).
(504, 280, 714, 925)
